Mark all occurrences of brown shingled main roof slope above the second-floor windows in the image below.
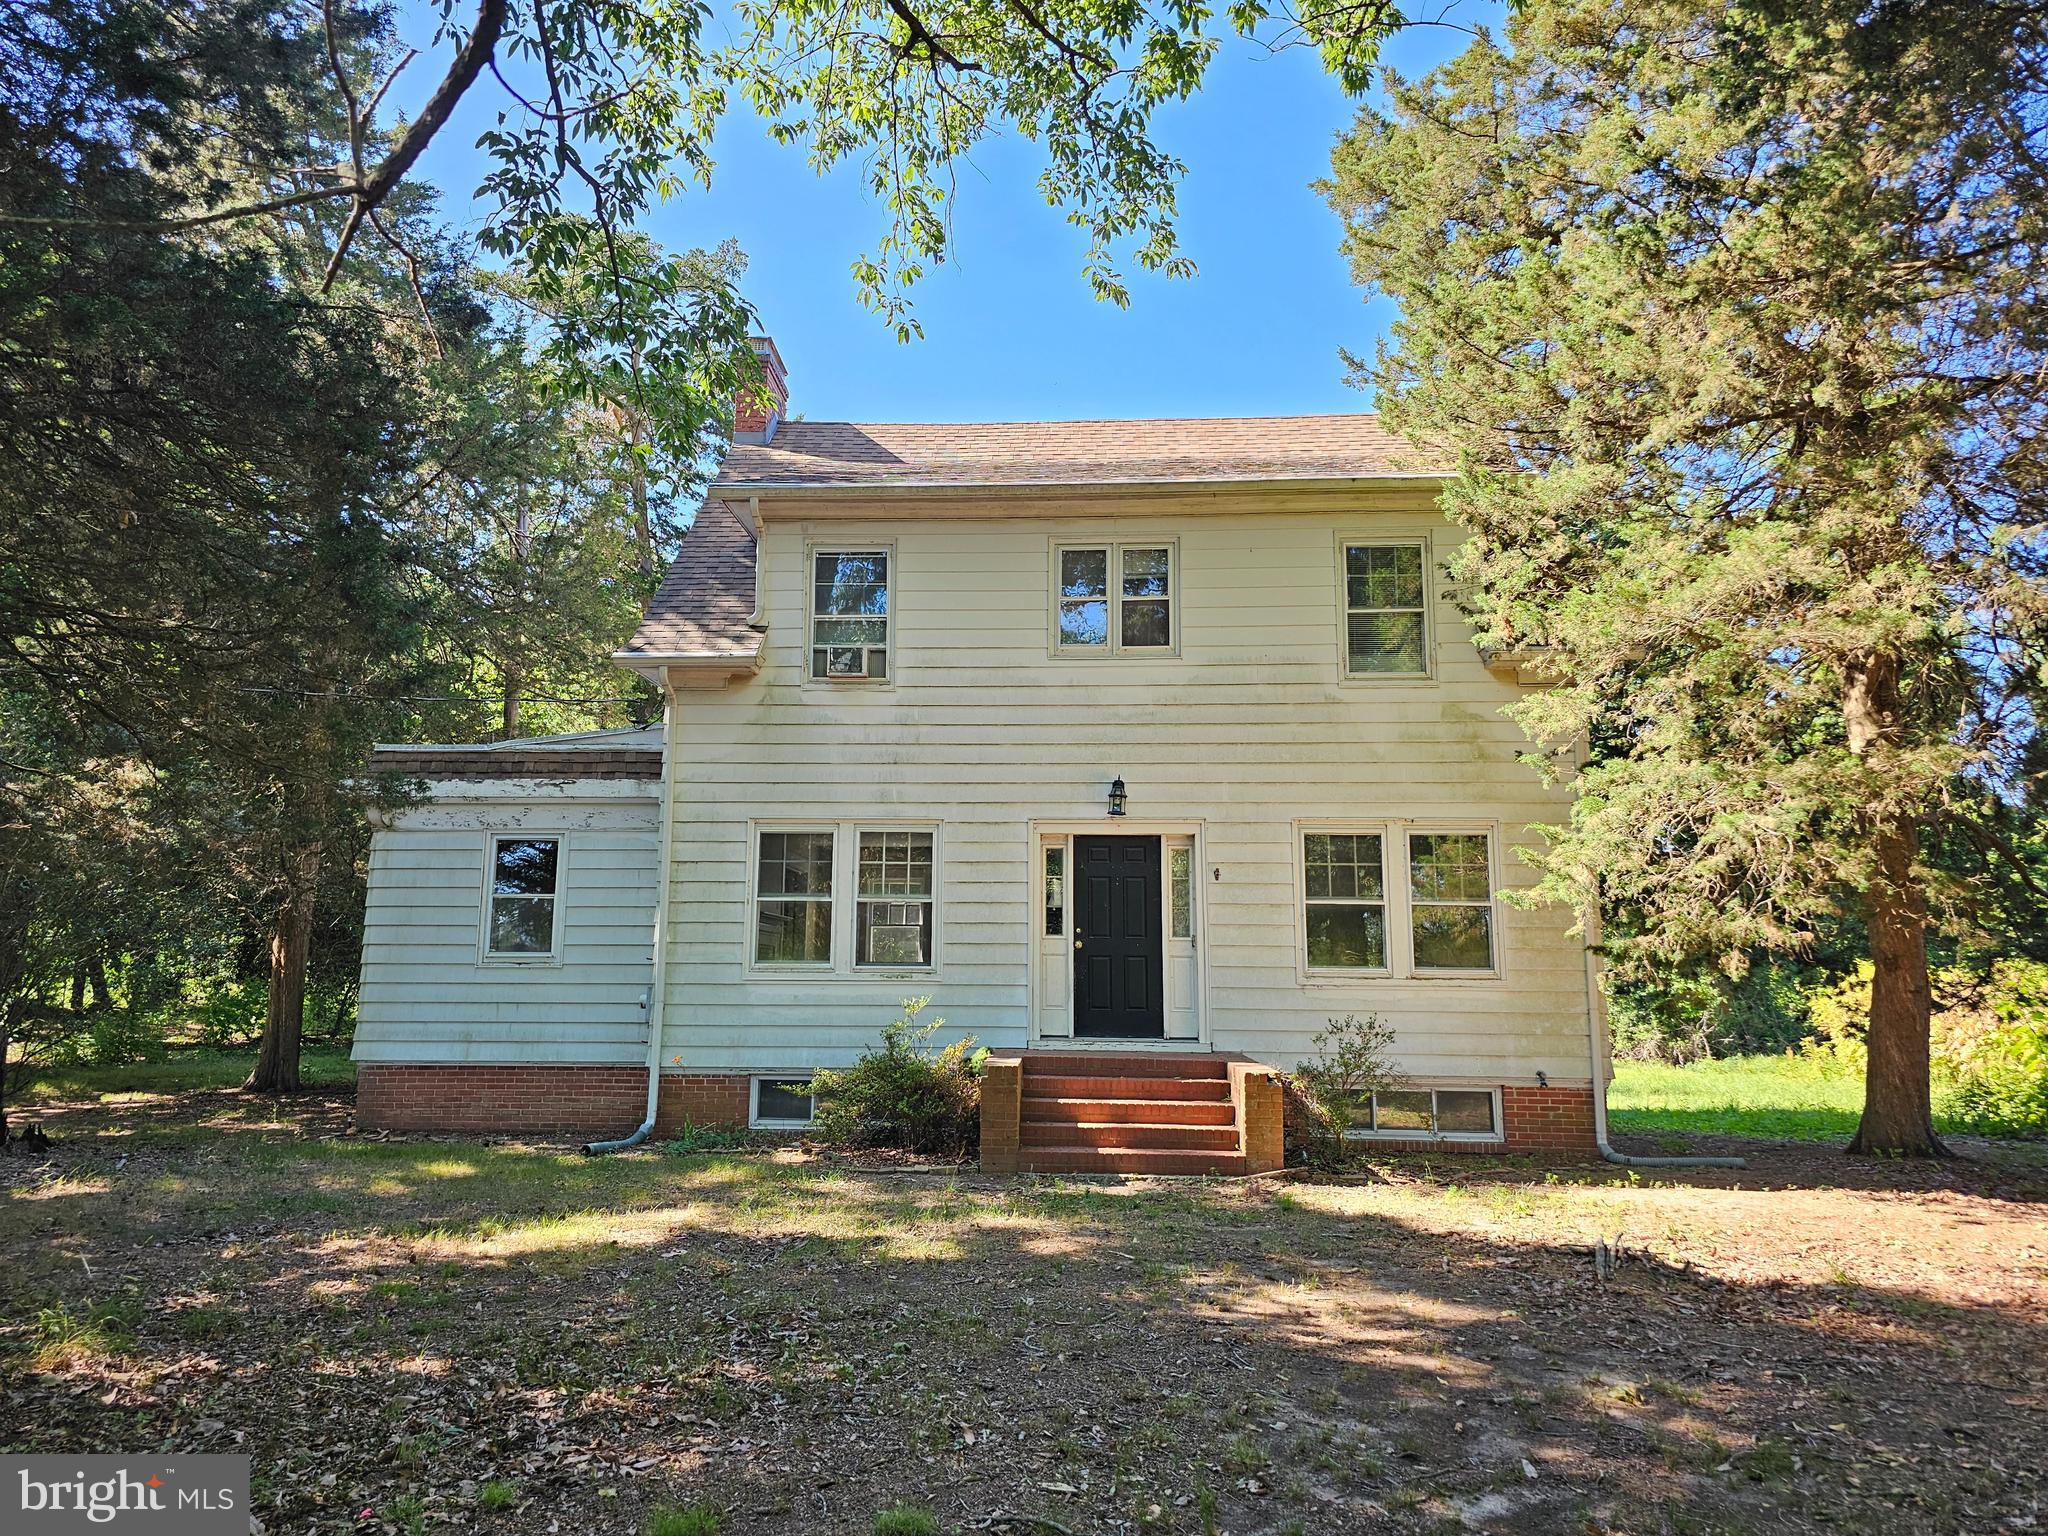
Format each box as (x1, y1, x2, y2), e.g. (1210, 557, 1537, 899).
(719, 414, 1450, 487)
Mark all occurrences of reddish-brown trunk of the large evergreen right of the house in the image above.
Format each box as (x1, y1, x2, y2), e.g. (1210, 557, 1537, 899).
(1843, 657, 1948, 1157)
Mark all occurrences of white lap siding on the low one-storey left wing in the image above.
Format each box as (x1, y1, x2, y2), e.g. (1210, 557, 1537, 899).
(354, 801, 659, 1083)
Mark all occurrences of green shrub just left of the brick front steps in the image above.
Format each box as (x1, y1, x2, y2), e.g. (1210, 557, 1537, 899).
(811, 997, 989, 1155)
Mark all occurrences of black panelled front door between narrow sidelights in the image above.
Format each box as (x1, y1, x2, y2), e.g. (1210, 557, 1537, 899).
(1073, 838, 1165, 1040)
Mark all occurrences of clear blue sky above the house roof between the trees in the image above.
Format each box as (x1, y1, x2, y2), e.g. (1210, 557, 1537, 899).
(406, 10, 1497, 422)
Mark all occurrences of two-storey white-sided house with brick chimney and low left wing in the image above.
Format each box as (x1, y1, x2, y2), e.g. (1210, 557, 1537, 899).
(356, 340, 1606, 1171)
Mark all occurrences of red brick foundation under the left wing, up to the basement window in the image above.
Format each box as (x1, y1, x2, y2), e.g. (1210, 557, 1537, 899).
(356, 1061, 750, 1137)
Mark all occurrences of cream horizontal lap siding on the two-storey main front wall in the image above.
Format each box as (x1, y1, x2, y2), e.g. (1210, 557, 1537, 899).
(664, 510, 1587, 1083)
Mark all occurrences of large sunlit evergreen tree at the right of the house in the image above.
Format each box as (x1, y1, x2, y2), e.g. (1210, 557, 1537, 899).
(1325, 0, 2048, 1153)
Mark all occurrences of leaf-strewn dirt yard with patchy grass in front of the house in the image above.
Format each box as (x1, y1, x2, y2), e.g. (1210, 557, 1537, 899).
(0, 1094, 2048, 1536)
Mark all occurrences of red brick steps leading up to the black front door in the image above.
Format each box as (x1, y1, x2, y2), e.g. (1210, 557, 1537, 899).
(1018, 1051, 1247, 1174)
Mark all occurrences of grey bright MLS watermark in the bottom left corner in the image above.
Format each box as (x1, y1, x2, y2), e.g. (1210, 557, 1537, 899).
(0, 1456, 250, 1536)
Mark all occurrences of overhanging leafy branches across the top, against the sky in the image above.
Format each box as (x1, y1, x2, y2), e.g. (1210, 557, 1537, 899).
(0, 0, 1403, 352)
